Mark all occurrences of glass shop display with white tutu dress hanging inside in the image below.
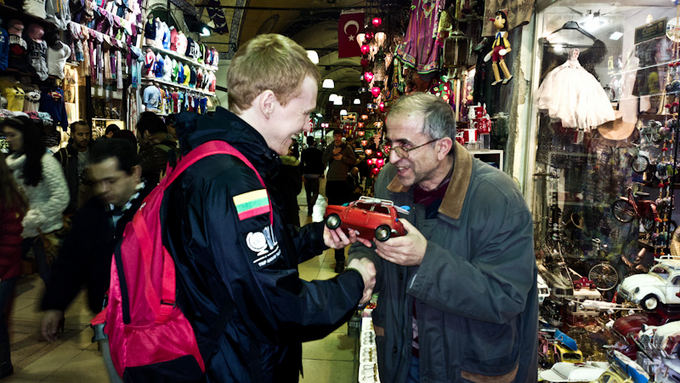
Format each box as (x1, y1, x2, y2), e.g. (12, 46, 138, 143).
(527, 0, 680, 284)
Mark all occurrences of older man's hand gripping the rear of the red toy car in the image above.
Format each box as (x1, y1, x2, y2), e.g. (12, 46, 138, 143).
(375, 218, 427, 266)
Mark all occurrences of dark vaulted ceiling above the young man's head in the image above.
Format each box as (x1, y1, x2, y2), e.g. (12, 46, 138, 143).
(190, 0, 410, 108)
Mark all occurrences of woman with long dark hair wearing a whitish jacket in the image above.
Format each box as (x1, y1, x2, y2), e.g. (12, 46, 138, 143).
(0, 117, 69, 281)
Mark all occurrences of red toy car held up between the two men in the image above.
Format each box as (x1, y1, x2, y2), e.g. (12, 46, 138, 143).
(326, 196, 408, 242)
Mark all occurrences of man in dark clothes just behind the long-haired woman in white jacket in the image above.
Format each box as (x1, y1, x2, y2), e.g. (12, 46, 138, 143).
(54, 121, 92, 215)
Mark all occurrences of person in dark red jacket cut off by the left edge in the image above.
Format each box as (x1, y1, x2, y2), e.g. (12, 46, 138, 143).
(0, 153, 28, 378)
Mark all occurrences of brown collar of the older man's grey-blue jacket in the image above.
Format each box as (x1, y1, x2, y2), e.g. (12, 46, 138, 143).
(387, 142, 472, 219)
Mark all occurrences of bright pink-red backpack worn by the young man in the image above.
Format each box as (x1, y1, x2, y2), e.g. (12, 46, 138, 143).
(92, 141, 264, 382)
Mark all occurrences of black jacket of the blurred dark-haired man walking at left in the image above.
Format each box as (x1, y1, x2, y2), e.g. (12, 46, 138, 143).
(41, 184, 151, 313)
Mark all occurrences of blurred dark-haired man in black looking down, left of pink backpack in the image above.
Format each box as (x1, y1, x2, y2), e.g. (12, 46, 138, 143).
(41, 138, 150, 341)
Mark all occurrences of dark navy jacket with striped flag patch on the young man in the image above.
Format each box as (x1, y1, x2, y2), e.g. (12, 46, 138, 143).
(161, 108, 363, 383)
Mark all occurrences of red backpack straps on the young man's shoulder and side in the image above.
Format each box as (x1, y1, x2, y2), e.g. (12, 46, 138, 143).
(159, 141, 274, 320)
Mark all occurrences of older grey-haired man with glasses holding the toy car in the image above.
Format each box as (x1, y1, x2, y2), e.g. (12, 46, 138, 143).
(349, 93, 538, 383)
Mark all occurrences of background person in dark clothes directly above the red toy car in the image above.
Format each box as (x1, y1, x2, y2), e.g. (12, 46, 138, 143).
(323, 129, 356, 273)
